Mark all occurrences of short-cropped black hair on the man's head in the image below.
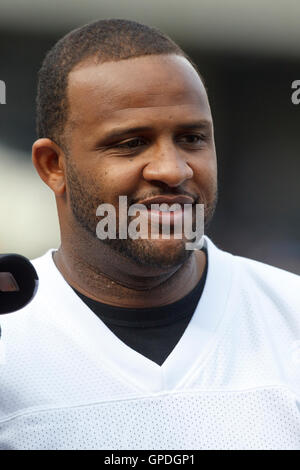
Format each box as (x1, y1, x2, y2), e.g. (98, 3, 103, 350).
(36, 18, 199, 147)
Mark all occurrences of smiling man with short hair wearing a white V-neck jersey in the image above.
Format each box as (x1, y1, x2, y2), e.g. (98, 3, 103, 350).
(0, 20, 300, 449)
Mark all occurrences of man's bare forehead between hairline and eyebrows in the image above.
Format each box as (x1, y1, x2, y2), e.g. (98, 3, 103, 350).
(68, 55, 210, 129)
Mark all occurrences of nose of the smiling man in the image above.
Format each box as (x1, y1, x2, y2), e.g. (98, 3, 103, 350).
(143, 143, 194, 187)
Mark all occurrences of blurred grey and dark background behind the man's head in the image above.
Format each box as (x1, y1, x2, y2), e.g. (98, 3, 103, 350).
(0, 0, 300, 274)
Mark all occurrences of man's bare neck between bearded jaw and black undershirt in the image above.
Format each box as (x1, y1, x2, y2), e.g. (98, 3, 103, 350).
(53, 240, 206, 308)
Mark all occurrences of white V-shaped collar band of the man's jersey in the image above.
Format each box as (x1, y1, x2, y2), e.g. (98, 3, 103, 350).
(33, 236, 234, 393)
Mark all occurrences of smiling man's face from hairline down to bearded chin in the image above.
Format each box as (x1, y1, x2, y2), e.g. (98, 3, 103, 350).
(66, 55, 217, 267)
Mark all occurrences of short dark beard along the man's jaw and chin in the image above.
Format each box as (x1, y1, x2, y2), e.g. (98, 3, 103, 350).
(66, 157, 218, 268)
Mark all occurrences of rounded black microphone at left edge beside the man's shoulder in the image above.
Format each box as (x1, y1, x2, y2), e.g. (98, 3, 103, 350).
(0, 254, 39, 314)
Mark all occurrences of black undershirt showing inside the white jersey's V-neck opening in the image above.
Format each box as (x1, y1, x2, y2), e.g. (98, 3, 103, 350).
(73, 248, 208, 366)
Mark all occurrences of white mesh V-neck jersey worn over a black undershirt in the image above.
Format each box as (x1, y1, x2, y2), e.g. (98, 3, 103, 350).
(0, 237, 300, 450)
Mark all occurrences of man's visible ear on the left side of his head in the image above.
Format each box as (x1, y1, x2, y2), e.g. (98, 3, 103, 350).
(32, 139, 66, 196)
